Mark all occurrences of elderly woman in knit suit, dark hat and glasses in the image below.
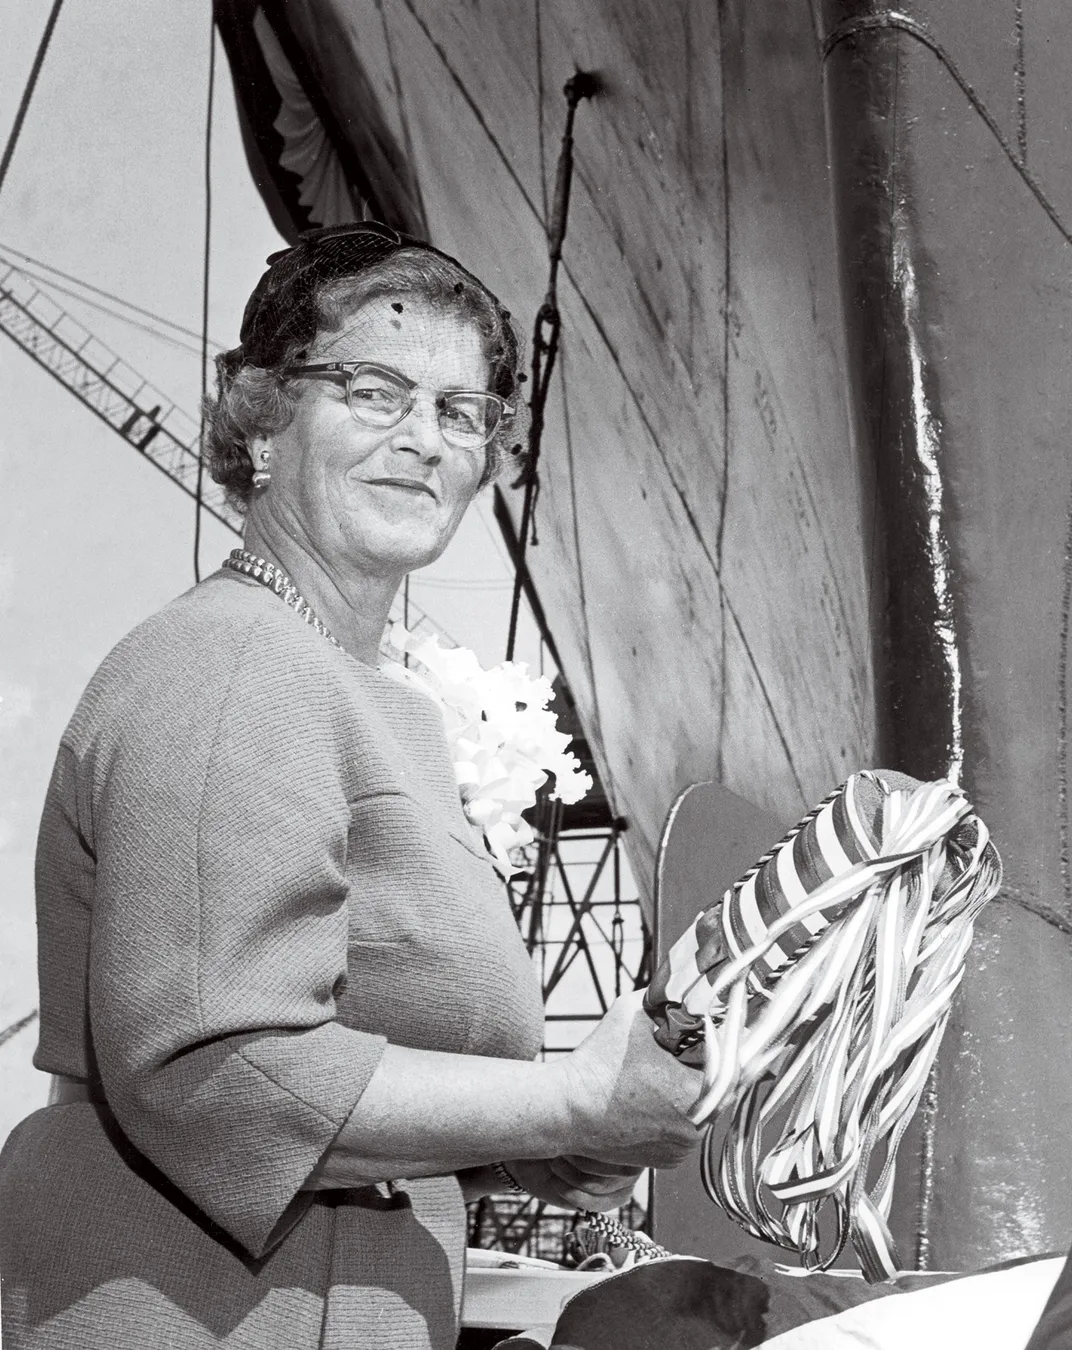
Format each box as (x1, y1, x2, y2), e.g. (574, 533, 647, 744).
(0, 224, 698, 1350)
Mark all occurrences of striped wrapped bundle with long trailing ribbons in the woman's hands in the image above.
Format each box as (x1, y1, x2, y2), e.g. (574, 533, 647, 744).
(645, 771, 1000, 1283)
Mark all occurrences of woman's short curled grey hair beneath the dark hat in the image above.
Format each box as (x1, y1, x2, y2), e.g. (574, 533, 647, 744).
(204, 247, 527, 510)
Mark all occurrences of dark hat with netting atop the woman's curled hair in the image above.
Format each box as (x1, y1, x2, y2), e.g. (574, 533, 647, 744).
(237, 220, 509, 369)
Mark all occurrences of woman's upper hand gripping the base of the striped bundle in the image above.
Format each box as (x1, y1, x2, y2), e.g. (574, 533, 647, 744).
(556, 990, 703, 1180)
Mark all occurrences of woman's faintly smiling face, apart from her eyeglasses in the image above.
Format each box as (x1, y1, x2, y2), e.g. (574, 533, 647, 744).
(252, 297, 489, 578)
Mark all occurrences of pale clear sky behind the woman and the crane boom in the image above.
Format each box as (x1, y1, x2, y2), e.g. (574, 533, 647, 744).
(0, 0, 540, 1141)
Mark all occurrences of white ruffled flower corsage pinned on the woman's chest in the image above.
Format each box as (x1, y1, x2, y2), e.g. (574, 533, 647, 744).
(381, 624, 591, 880)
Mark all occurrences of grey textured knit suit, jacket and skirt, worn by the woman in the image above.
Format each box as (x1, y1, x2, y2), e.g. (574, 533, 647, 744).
(0, 572, 543, 1350)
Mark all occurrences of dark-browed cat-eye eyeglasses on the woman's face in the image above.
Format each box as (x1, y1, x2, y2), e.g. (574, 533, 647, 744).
(284, 360, 514, 450)
